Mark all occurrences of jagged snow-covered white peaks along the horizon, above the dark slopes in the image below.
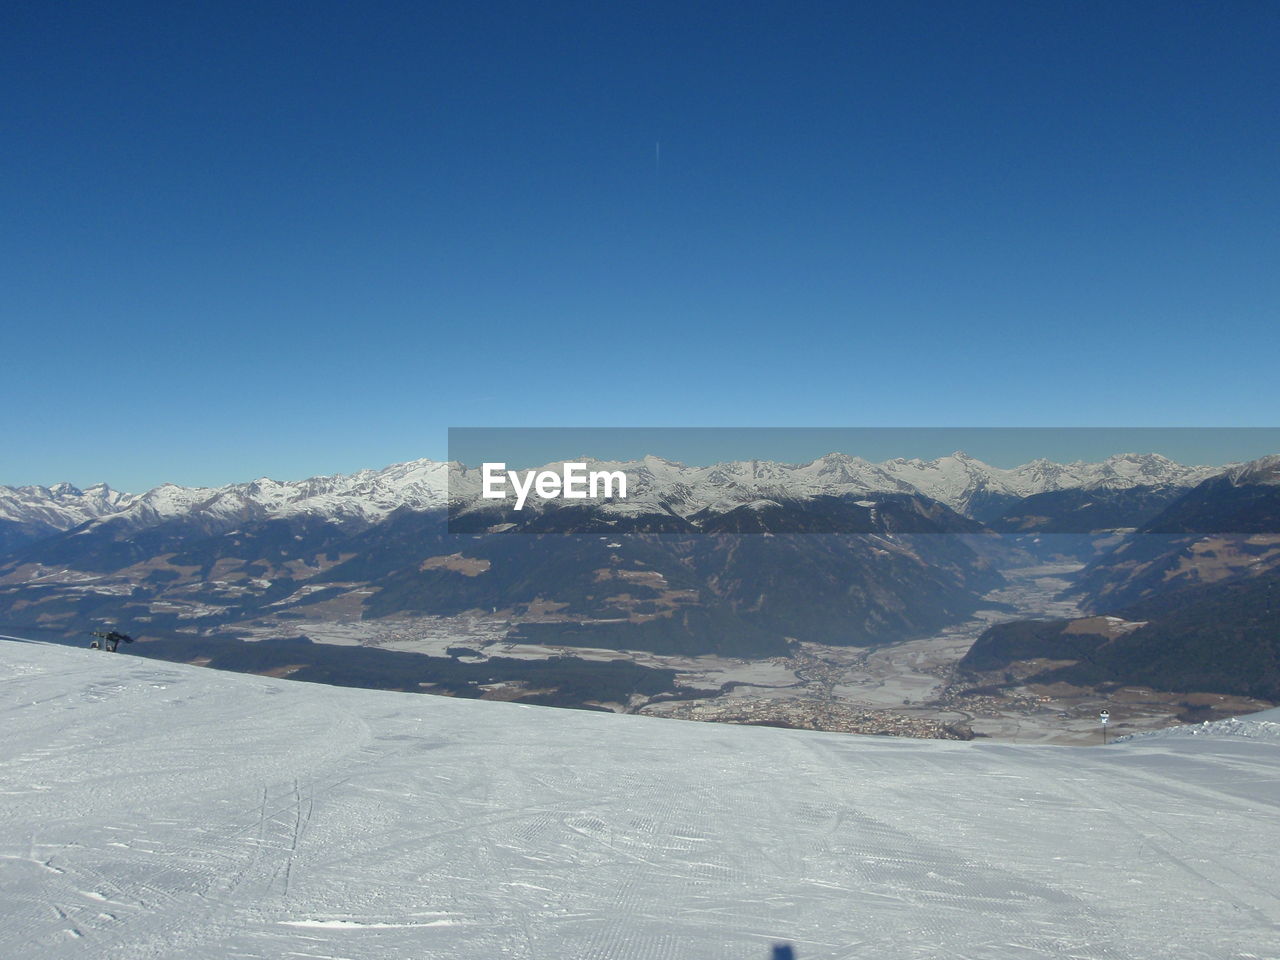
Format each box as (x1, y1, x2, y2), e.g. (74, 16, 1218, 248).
(0, 452, 1225, 549)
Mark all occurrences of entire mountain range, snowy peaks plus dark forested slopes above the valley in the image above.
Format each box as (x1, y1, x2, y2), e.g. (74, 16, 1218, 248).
(0, 453, 1280, 695)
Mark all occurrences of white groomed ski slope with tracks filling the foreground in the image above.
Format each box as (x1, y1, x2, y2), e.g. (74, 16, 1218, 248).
(0, 641, 1280, 960)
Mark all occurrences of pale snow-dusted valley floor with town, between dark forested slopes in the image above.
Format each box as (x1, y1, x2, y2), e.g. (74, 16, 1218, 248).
(222, 563, 1271, 745)
